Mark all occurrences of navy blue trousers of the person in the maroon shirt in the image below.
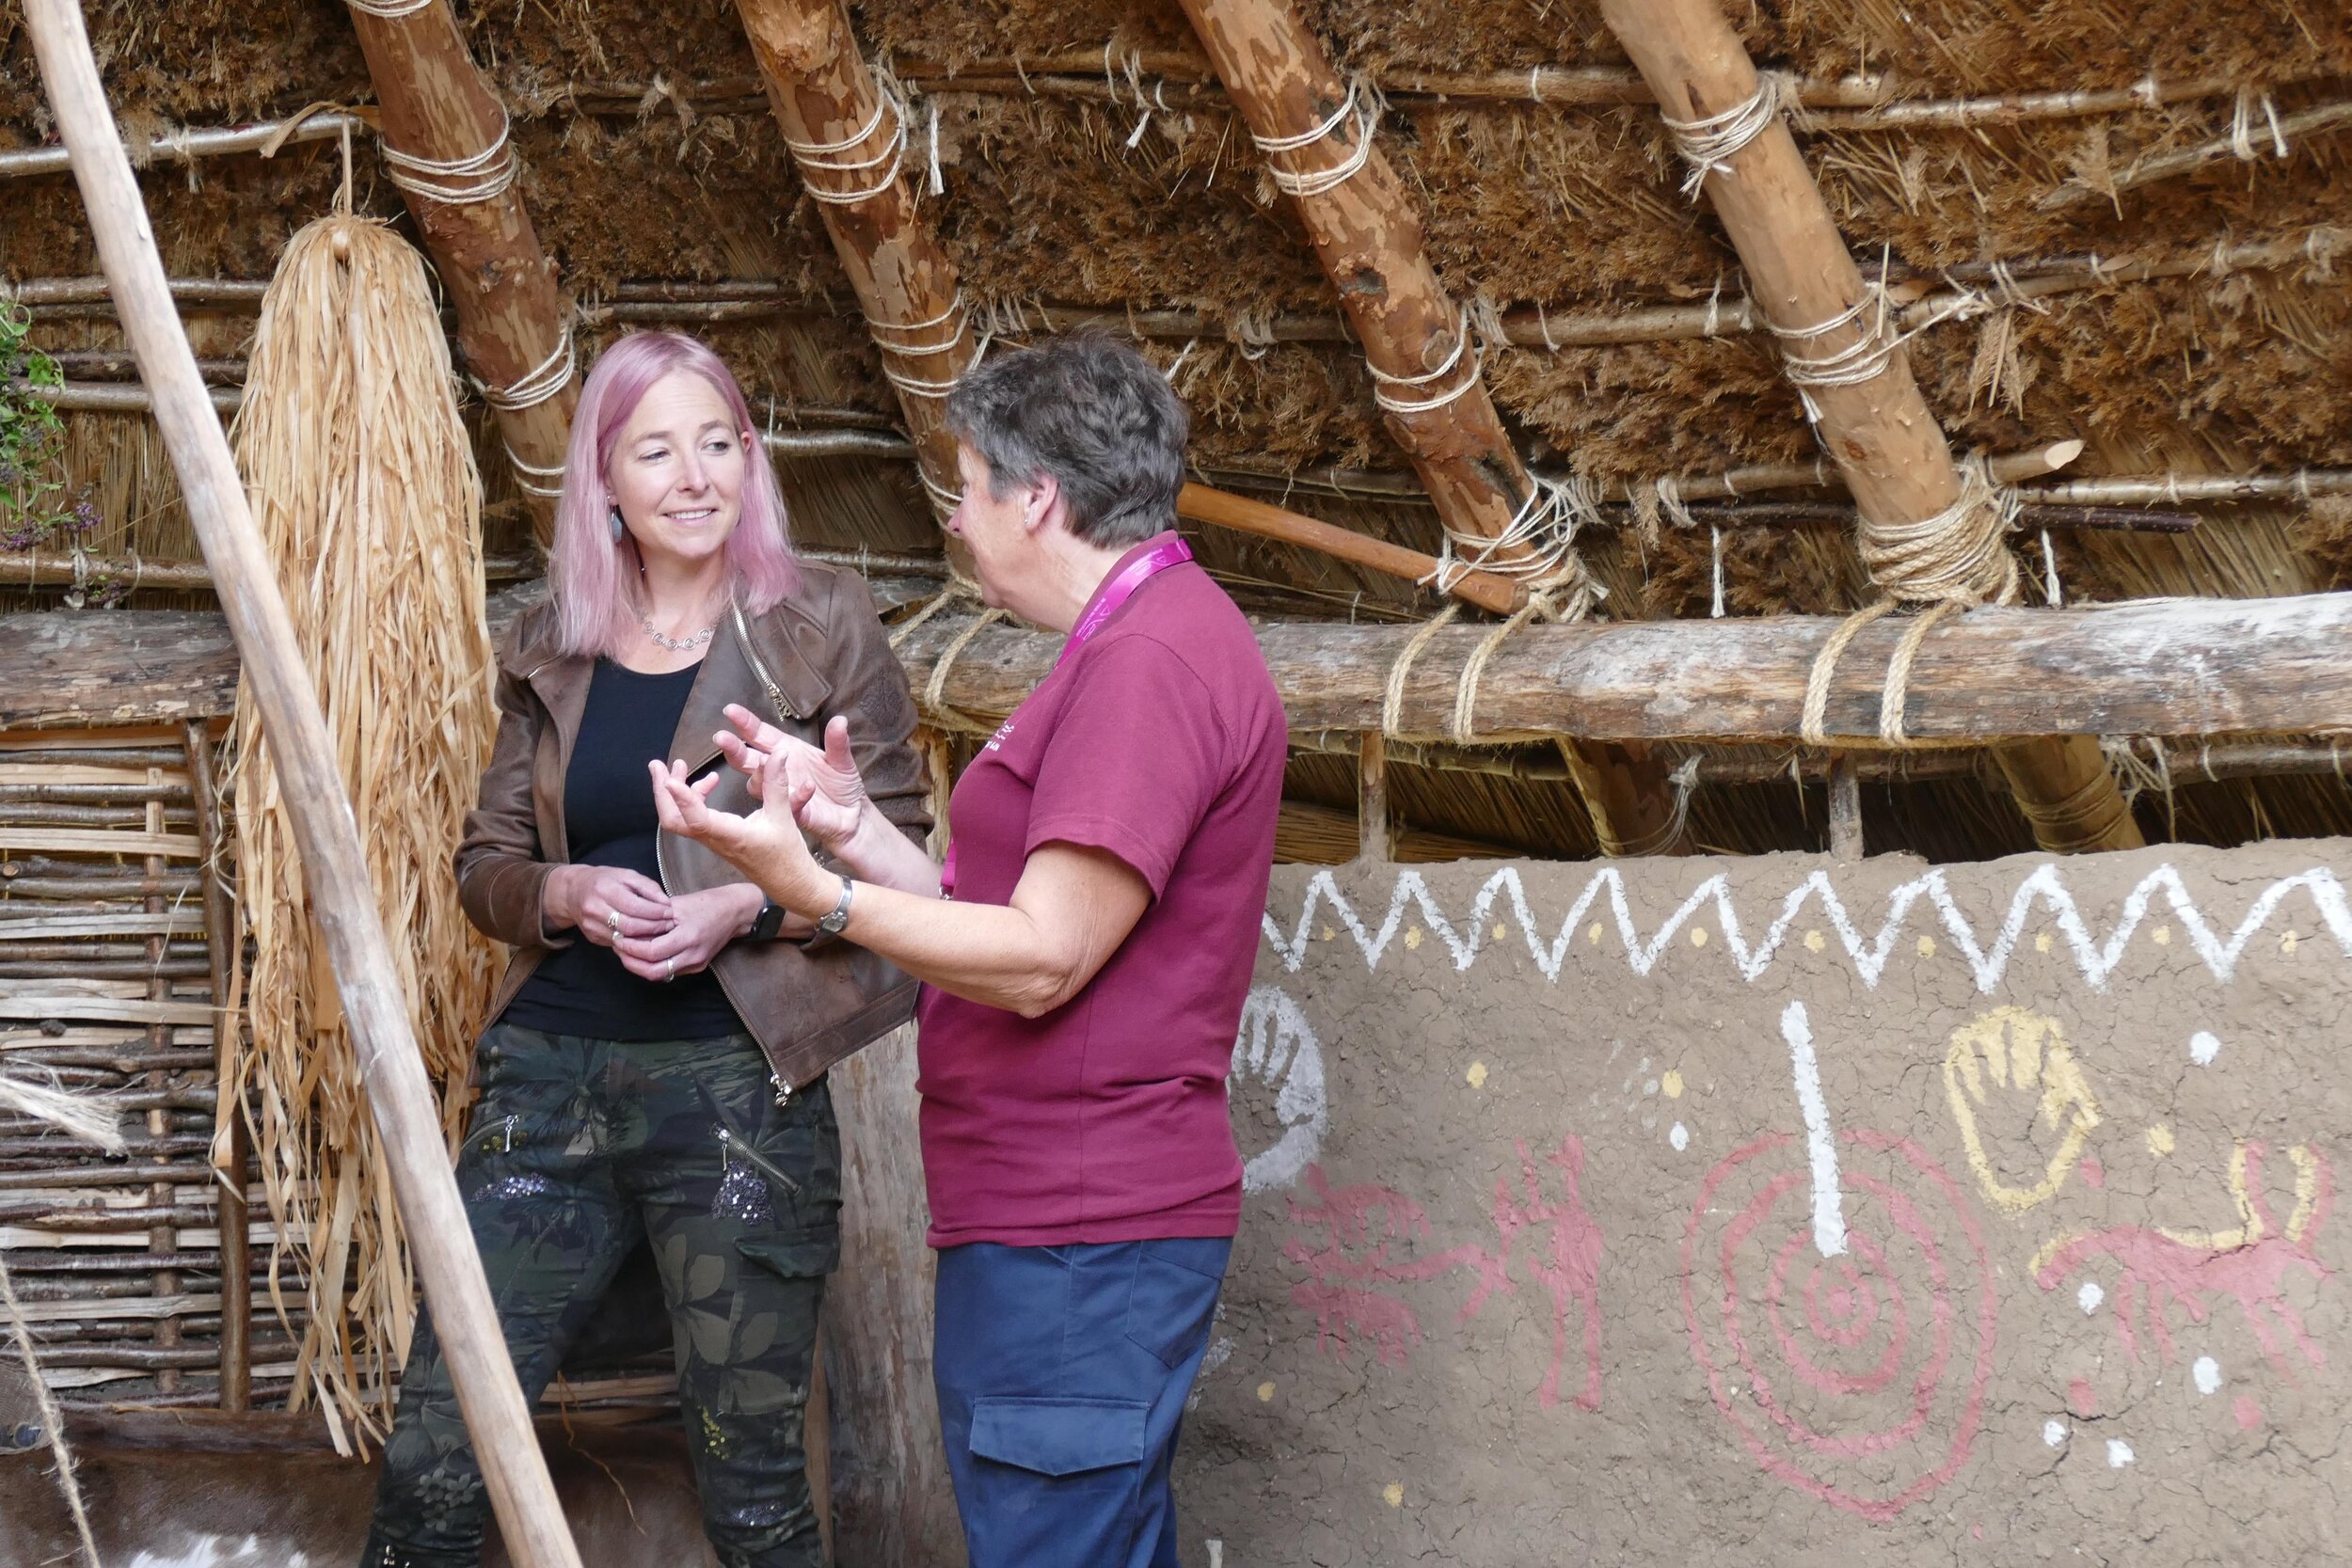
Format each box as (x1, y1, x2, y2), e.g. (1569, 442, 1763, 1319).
(931, 1239, 1232, 1568)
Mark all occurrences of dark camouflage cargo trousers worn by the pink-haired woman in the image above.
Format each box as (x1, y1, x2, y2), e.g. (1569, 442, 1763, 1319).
(362, 1025, 842, 1568)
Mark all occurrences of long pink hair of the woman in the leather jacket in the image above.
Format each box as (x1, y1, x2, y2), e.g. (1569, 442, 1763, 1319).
(548, 331, 800, 656)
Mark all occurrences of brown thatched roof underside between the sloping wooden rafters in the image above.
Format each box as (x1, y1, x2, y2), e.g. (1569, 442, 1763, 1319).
(0, 0, 2352, 858)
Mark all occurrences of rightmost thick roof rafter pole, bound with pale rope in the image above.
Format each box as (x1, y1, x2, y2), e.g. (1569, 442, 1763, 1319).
(1602, 0, 2145, 851)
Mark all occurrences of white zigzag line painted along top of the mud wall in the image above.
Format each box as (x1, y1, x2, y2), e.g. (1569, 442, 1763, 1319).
(1263, 863, 2352, 992)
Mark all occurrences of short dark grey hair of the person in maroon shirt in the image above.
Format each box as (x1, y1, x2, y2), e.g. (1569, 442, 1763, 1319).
(946, 334, 1193, 550)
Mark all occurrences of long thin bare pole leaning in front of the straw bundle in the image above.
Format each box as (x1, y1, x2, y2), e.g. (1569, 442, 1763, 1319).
(24, 0, 579, 1568)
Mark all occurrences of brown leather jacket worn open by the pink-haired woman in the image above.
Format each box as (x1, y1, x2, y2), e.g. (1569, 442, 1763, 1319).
(456, 562, 931, 1098)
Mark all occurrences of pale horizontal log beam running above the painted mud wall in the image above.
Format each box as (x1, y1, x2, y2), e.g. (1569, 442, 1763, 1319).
(898, 594, 2352, 748)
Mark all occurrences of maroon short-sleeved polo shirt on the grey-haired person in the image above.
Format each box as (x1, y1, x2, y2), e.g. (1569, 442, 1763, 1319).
(917, 533, 1289, 1246)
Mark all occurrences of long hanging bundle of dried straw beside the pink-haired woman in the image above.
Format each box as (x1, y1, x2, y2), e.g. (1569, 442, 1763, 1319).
(233, 214, 497, 1441)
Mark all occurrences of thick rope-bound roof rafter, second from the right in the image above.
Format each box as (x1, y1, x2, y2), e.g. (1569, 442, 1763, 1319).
(1184, 0, 1684, 853)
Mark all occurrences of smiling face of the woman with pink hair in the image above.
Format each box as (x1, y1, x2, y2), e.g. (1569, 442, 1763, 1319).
(605, 372, 753, 562)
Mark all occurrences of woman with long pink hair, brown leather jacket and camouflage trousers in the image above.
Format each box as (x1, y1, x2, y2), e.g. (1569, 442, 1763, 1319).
(365, 331, 930, 1568)
